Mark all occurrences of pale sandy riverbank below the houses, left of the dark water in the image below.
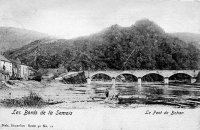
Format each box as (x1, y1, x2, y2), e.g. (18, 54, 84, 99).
(0, 81, 113, 108)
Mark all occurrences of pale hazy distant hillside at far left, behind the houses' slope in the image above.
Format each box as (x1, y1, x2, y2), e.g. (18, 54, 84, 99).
(0, 27, 49, 52)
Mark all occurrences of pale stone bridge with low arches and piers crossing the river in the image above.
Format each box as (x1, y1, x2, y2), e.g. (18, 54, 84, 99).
(85, 70, 200, 84)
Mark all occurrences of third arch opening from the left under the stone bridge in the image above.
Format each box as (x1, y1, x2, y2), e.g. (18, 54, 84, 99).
(141, 73, 165, 82)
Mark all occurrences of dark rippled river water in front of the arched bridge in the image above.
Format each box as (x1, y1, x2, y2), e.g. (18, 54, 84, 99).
(89, 83, 200, 108)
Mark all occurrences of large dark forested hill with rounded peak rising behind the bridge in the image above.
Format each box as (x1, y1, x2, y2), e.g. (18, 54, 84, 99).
(5, 19, 200, 70)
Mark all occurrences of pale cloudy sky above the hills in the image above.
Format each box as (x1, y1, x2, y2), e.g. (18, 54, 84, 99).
(0, 0, 200, 39)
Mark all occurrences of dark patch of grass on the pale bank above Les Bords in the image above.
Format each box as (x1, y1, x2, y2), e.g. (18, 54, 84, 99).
(1, 92, 49, 108)
